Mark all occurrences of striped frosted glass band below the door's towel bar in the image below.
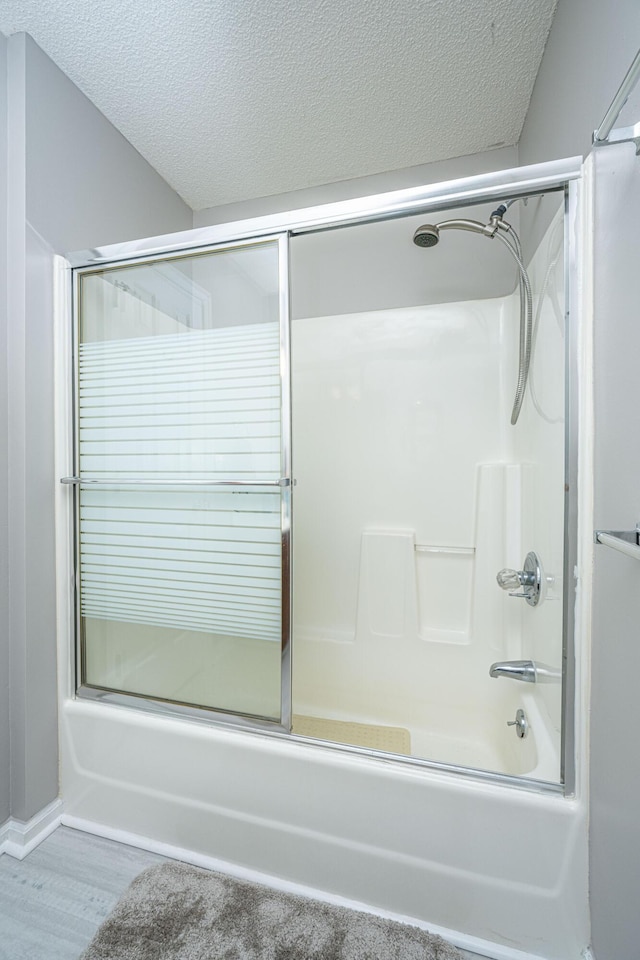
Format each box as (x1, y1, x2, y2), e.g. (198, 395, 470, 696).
(80, 487, 281, 642)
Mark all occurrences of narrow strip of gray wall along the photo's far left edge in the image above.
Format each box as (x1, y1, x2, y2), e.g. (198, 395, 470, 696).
(0, 34, 10, 825)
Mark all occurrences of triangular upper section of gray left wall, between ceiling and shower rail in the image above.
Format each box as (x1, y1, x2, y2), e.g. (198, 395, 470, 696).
(23, 34, 193, 253)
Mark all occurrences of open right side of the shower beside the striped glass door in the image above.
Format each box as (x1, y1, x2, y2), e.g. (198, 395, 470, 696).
(292, 194, 565, 782)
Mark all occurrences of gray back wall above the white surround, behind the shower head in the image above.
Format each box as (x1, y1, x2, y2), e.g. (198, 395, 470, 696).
(194, 147, 519, 318)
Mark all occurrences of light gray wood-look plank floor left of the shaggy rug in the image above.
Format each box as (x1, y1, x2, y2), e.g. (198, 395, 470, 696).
(0, 827, 165, 960)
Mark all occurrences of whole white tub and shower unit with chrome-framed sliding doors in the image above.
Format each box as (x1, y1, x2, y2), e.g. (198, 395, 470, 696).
(56, 154, 592, 960)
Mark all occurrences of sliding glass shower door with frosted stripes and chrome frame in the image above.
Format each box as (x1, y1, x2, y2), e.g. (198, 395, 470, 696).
(69, 237, 291, 725)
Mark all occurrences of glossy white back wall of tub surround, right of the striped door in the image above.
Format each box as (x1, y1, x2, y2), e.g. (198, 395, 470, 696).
(292, 299, 531, 773)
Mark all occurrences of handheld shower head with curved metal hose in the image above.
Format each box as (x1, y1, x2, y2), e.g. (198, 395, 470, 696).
(413, 200, 533, 426)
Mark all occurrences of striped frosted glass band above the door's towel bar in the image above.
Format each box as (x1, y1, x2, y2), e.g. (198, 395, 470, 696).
(79, 323, 280, 480)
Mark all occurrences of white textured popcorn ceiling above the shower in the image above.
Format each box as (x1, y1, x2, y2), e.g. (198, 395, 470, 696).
(0, 0, 556, 210)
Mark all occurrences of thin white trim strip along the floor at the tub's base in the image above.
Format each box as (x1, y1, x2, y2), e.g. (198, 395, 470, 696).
(61, 813, 552, 960)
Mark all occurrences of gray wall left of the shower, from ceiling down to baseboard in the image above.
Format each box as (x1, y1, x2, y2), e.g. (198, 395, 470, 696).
(0, 34, 192, 820)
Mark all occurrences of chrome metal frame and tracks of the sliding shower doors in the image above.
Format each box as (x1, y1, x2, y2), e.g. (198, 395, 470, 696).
(61, 157, 582, 795)
